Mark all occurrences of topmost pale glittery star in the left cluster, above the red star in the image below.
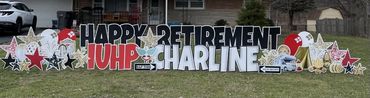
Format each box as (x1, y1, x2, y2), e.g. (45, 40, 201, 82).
(17, 27, 42, 44)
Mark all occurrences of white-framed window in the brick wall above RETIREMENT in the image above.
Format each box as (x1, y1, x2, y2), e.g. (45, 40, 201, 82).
(175, 0, 205, 9)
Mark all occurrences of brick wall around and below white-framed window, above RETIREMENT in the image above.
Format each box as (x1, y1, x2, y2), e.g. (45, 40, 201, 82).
(168, 0, 243, 25)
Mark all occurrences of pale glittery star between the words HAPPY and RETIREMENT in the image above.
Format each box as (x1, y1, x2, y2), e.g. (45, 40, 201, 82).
(138, 28, 163, 47)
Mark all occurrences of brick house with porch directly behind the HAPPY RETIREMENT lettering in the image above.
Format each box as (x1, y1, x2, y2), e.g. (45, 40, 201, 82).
(74, 0, 243, 25)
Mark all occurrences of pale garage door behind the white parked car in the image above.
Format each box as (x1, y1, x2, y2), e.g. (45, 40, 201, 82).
(16, 0, 73, 28)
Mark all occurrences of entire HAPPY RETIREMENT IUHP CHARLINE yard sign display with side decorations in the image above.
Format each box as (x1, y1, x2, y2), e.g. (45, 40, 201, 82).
(0, 24, 366, 75)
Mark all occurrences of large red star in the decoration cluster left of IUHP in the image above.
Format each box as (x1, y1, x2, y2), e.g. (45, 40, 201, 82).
(26, 48, 44, 70)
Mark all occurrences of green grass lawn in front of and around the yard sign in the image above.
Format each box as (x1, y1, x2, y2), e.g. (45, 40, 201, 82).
(0, 34, 370, 98)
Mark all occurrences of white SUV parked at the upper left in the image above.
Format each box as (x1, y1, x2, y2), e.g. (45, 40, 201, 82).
(0, 1, 37, 34)
